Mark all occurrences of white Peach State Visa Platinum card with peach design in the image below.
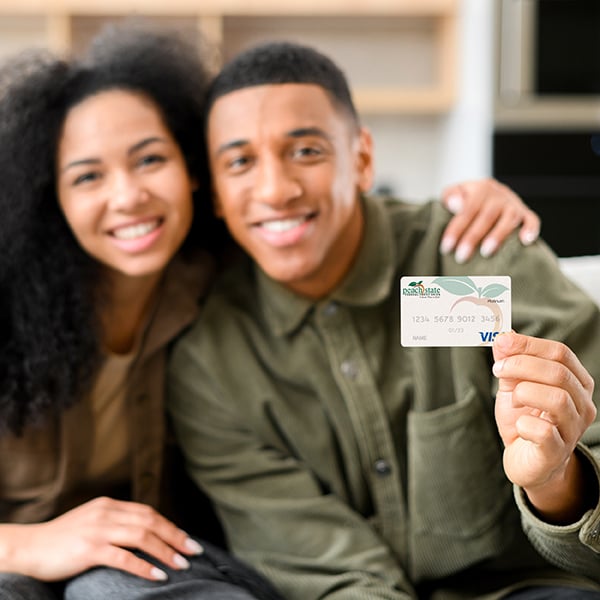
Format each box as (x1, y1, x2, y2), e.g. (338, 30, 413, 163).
(400, 275, 511, 347)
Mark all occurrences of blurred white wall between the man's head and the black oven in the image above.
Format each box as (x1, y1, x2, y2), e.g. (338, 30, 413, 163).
(364, 0, 494, 201)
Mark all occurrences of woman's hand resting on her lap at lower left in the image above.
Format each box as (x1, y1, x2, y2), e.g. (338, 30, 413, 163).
(0, 498, 202, 581)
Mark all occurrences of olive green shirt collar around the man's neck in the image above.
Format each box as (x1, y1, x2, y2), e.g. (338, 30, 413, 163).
(254, 198, 395, 335)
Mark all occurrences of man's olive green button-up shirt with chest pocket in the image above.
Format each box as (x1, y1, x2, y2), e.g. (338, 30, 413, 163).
(168, 199, 600, 600)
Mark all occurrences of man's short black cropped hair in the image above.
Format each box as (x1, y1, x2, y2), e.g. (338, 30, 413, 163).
(207, 42, 359, 124)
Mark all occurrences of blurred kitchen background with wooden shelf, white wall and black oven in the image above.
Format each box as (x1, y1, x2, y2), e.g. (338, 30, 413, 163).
(0, 0, 600, 257)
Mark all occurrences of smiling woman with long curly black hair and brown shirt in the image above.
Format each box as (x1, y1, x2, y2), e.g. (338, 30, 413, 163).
(0, 18, 536, 600)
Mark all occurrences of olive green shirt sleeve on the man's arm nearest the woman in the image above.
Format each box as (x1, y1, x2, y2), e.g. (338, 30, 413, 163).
(168, 310, 416, 600)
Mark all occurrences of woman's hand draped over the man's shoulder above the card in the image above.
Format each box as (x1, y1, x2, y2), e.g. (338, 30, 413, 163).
(440, 179, 540, 263)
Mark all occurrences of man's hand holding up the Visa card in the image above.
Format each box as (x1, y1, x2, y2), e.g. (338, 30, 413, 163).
(493, 333, 596, 523)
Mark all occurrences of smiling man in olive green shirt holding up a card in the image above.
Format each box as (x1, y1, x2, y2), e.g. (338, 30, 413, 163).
(169, 44, 600, 600)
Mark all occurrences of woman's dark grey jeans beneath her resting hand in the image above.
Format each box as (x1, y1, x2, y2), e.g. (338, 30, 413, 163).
(0, 542, 282, 600)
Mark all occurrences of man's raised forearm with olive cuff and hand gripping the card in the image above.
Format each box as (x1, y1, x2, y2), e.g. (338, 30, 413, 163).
(494, 333, 600, 580)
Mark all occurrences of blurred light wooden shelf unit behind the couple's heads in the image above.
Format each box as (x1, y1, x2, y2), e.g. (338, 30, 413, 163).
(0, 0, 458, 114)
